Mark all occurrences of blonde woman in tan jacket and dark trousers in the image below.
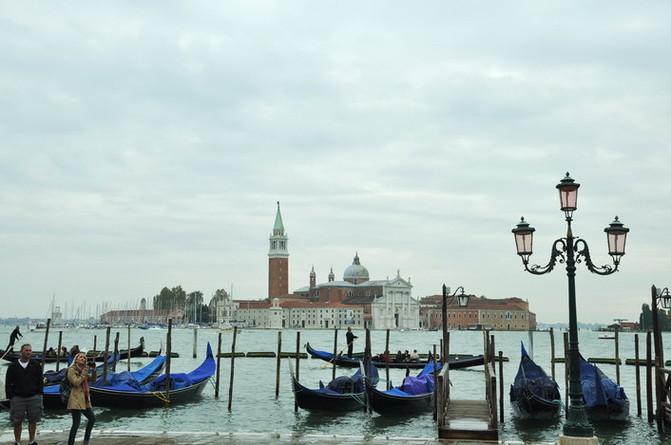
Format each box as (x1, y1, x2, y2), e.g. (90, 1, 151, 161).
(67, 352, 96, 445)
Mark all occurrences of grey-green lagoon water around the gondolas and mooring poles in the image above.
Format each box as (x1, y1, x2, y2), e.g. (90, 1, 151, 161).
(0, 328, 671, 444)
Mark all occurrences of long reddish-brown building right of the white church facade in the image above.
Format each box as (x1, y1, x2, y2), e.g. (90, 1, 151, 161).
(420, 295, 536, 331)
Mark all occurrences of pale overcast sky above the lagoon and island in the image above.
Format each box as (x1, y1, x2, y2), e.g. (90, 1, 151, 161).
(0, 0, 671, 323)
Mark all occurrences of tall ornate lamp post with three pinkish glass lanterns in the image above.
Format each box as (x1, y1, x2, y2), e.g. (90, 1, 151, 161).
(512, 173, 629, 437)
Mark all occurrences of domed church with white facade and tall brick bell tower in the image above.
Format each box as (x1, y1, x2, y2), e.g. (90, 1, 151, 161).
(233, 202, 419, 329)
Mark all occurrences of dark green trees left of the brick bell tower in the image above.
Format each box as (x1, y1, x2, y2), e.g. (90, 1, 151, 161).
(152, 286, 228, 323)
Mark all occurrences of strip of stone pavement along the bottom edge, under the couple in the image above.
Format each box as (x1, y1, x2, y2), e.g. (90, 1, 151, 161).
(0, 428, 550, 445)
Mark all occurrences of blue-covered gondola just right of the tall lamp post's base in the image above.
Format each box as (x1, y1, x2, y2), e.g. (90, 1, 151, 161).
(580, 356, 629, 421)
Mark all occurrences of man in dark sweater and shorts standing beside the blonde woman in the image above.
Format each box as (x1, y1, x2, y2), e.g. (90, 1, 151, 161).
(5, 344, 44, 445)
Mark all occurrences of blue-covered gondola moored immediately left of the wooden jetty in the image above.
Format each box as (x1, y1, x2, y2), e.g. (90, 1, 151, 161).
(366, 362, 441, 416)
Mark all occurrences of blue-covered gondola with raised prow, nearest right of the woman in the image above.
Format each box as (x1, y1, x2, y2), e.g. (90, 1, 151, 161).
(86, 343, 217, 409)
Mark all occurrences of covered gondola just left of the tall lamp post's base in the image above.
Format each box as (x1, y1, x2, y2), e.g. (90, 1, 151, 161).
(510, 343, 561, 419)
